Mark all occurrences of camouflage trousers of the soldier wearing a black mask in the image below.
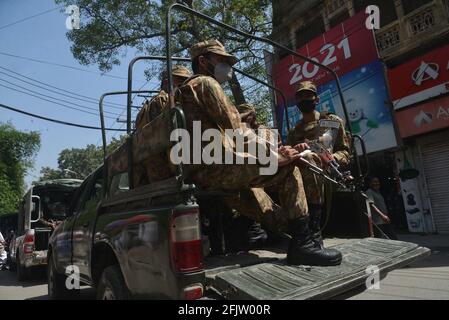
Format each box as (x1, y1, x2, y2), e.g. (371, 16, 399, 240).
(298, 153, 324, 206)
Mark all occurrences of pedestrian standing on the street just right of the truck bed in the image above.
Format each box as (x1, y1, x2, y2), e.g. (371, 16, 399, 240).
(366, 177, 398, 240)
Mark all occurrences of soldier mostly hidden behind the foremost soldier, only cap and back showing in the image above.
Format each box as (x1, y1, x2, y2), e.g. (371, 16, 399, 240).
(136, 65, 191, 130)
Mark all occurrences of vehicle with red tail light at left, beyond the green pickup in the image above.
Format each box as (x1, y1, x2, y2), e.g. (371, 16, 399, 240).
(10, 179, 82, 280)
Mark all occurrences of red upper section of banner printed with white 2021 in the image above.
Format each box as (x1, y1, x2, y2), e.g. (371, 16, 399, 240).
(272, 11, 378, 99)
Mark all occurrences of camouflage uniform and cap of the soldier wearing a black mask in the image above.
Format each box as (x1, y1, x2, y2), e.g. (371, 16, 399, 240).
(287, 81, 350, 205)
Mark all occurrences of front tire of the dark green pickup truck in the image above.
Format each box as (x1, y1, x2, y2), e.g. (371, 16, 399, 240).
(47, 255, 79, 300)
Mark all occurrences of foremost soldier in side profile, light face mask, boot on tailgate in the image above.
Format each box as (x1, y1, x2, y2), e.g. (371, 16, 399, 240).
(176, 40, 341, 265)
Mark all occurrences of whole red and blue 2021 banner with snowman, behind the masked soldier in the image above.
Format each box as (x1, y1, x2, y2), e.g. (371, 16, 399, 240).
(272, 12, 397, 153)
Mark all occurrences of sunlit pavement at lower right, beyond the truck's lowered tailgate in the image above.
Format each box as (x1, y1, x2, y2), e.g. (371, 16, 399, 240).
(342, 234, 449, 300)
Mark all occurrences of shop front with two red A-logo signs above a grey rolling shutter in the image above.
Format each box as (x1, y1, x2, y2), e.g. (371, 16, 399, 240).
(388, 45, 449, 233)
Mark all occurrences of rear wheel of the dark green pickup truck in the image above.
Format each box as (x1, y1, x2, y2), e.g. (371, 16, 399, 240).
(97, 265, 130, 300)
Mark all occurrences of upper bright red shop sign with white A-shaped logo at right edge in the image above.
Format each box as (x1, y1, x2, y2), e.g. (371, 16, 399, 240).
(388, 45, 449, 109)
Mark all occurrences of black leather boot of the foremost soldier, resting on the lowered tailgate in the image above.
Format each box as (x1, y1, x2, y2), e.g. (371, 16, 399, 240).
(287, 216, 342, 266)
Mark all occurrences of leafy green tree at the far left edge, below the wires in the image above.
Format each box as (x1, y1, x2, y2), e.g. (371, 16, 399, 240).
(0, 122, 40, 214)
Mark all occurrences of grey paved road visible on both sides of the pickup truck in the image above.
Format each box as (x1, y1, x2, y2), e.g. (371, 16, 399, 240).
(0, 235, 449, 300)
